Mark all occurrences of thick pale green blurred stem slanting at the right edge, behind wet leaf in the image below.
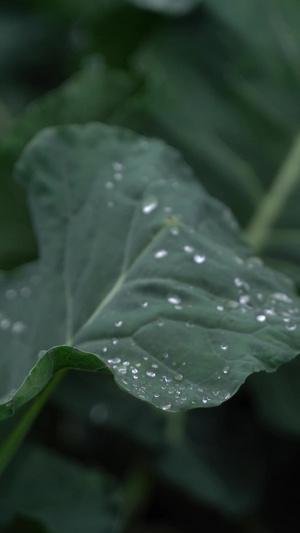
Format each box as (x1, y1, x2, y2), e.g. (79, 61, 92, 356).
(246, 135, 300, 252)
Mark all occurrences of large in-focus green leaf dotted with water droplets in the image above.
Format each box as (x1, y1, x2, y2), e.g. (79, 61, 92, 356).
(0, 124, 300, 417)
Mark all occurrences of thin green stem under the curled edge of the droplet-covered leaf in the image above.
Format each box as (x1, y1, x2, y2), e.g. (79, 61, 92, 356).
(0, 371, 65, 476)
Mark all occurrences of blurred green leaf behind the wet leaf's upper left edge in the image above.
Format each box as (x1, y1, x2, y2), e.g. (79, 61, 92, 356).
(0, 57, 135, 268)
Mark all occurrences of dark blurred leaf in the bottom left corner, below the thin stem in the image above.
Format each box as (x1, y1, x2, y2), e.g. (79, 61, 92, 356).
(0, 447, 121, 533)
